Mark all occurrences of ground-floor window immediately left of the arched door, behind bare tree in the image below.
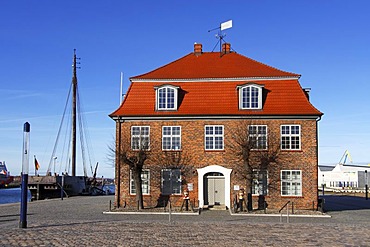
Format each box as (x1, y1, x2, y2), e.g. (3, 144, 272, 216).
(162, 169, 181, 195)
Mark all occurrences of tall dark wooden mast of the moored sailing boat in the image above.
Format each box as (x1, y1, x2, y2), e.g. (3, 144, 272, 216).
(71, 49, 77, 176)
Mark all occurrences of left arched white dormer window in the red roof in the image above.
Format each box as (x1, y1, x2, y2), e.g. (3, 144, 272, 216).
(155, 85, 179, 111)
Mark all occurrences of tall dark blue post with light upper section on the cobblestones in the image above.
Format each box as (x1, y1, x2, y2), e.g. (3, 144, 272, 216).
(19, 122, 30, 228)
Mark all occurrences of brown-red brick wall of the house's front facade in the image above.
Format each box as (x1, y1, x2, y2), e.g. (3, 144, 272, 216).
(116, 119, 318, 209)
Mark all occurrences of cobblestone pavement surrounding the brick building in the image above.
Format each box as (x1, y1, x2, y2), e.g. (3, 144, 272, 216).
(0, 196, 370, 246)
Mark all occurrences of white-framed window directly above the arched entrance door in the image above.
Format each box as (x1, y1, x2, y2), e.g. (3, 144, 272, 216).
(204, 125, 224, 150)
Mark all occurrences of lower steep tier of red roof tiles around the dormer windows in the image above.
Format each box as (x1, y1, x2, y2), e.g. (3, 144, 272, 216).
(111, 80, 321, 117)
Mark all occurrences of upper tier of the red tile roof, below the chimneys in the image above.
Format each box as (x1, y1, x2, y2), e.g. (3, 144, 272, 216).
(131, 52, 299, 79)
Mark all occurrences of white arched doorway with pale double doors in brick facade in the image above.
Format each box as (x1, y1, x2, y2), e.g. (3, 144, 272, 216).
(197, 165, 231, 208)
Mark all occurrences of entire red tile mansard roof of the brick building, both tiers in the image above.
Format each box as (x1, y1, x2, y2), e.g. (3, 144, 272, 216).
(110, 52, 322, 118)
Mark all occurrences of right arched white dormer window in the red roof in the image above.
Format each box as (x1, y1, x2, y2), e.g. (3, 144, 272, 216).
(238, 84, 263, 109)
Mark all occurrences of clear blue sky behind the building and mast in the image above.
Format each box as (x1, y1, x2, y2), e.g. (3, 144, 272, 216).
(0, 0, 370, 177)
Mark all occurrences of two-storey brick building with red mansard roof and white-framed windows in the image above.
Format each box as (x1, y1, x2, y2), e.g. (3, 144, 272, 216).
(110, 43, 322, 209)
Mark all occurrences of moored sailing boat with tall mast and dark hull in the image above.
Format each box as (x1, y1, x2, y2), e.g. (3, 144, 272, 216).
(28, 50, 96, 200)
